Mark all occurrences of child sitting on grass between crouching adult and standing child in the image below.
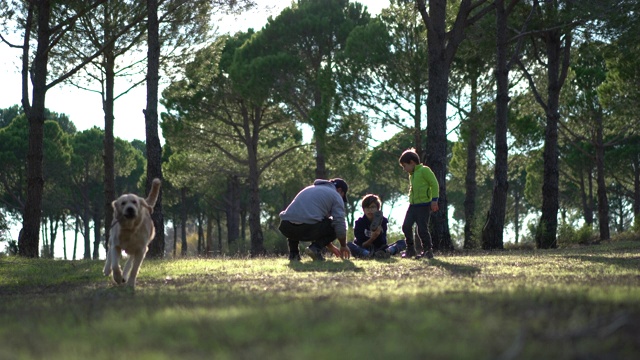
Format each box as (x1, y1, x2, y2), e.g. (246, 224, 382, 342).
(347, 194, 406, 259)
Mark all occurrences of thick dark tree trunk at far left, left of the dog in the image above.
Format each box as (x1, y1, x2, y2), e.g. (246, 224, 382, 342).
(18, 0, 51, 258)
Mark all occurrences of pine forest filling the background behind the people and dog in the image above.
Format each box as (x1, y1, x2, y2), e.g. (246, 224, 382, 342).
(0, 0, 640, 256)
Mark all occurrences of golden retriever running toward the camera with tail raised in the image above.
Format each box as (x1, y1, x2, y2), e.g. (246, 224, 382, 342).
(104, 179, 160, 288)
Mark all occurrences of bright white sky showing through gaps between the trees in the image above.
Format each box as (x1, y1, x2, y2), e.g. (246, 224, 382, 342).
(0, 0, 404, 258)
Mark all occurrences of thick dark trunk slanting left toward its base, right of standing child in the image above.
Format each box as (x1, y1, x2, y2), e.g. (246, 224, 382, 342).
(482, 0, 509, 250)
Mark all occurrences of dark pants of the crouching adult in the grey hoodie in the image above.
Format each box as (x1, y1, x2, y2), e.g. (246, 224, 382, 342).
(278, 218, 336, 254)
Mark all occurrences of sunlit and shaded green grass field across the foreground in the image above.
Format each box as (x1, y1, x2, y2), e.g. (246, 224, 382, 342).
(0, 241, 640, 360)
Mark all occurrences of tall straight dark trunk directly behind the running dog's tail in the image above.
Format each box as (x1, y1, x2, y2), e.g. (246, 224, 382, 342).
(144, 0, 164, 258)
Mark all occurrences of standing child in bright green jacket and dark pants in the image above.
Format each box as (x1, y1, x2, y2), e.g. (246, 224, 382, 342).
(400, 148, 440, 259)
